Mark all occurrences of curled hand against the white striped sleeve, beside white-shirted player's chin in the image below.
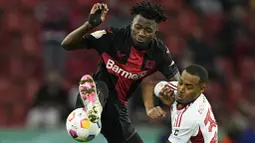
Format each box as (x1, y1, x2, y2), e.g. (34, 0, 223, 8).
(159, 85, 175, 106)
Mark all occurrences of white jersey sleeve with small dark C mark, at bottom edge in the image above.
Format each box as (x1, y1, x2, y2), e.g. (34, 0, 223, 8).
(168, 123, 199, 143)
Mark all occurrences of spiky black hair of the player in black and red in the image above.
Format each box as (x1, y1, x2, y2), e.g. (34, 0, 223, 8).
(131, 0, 167, 23)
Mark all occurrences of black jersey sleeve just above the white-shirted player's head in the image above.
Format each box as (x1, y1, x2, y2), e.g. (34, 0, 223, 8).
(158, 43, 179, 79)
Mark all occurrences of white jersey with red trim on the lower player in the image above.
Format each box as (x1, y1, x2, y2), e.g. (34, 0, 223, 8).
(168, 82, 218, 143)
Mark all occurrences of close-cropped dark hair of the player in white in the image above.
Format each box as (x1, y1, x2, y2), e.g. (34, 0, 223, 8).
(184, 64, 209, 83)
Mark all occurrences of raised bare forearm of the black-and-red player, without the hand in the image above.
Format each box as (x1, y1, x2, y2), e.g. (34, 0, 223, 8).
(61, 22, 94, 50)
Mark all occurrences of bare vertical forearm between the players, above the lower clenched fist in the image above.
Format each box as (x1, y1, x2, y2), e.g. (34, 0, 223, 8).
(142, 81, 156, 111)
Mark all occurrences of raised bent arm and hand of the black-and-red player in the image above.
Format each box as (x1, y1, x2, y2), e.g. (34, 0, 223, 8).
(61, 3, 109, 50)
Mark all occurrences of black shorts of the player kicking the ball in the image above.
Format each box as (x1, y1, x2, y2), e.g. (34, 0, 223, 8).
(76, 82, 141, 143)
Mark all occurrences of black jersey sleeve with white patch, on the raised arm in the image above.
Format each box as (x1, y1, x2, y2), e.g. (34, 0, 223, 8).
(82, 28, 114, 53)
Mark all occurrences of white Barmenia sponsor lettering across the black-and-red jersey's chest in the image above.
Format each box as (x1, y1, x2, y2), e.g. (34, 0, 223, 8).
(106, 59, 147, 80)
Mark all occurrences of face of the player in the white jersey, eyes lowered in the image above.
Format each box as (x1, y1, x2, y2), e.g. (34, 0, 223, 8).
(175, 70, 205, 104)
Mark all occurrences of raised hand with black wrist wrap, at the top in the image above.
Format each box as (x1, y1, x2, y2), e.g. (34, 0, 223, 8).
(89, 3, 109, 27)
